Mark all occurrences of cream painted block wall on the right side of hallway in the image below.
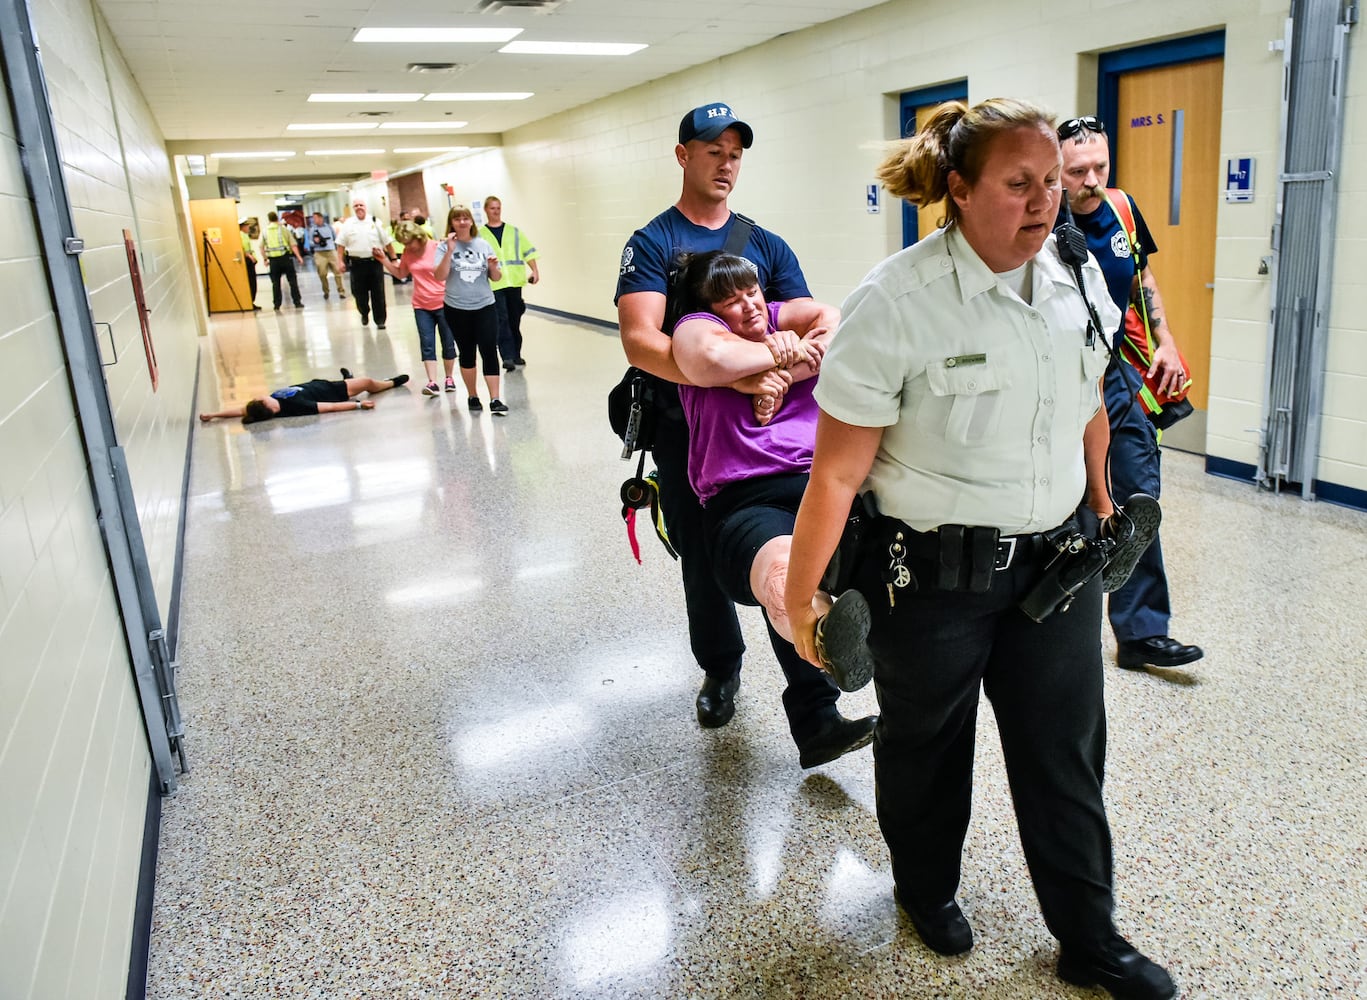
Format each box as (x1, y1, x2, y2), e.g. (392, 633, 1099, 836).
(415, 0, 1367, 489)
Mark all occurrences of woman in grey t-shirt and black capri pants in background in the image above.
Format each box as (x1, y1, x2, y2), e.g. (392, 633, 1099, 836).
(432, 205, 509, 414)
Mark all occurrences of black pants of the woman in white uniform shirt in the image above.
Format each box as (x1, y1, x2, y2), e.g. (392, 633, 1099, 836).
(856, 530, 1115, 954)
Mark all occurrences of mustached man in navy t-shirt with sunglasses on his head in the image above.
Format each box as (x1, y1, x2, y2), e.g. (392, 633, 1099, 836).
(1058, 117, 1204, 669)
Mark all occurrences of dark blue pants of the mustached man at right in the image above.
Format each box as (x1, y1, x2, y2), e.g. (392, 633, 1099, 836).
(1105, 362, 1172, 642)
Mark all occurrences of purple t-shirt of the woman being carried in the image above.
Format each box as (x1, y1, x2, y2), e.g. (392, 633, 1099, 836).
(679, 302, 817, 505)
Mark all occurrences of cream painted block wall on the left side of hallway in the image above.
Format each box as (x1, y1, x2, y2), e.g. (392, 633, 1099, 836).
(0, 0, 200, 1000)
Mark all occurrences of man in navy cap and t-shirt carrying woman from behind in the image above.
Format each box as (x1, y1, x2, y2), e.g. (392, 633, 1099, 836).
(614, 104, 876, 766)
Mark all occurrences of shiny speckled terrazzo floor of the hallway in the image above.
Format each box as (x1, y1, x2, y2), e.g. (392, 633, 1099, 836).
(148, 281, 1367, 1000)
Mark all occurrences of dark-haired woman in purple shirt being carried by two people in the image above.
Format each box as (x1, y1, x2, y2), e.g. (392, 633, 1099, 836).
(673, 251, 874, 691)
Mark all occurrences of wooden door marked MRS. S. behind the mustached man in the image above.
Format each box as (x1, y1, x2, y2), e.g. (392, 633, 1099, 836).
(1110, 57, 1225, 410)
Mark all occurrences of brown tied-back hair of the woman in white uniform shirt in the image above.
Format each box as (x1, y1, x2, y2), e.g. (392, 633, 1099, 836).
(875, 97, 1054, 225)
